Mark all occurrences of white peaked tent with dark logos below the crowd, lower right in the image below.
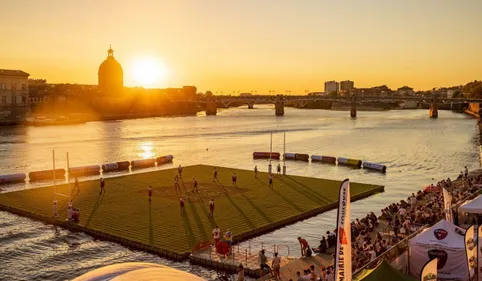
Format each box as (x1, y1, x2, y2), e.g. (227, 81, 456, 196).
(408, 220, 468, 281)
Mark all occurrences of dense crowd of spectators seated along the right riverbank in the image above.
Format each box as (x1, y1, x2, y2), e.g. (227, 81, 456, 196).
(264, 165, 482, 281)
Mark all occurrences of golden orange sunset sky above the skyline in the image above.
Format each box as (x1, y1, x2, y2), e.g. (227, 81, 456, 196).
(0, 0, 482, 94)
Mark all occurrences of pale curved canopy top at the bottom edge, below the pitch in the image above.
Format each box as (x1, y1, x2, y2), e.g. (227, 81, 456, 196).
(72, 262, 206, 281)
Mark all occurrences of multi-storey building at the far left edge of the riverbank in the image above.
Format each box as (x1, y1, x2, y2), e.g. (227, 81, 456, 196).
(0, 69, 30, 120)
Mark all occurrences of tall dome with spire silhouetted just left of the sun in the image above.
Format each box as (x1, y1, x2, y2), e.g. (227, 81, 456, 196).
(98, 47, 124, 94)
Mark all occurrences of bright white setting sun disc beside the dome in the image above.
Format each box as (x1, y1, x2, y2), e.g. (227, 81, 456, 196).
(132, 58, 166, 88)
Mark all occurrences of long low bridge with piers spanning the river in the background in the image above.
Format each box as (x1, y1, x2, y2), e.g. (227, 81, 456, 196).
(196, 95, 482, 118)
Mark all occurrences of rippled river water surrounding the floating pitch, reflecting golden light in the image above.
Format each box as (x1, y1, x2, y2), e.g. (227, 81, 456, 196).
(0, 106, 480, 280)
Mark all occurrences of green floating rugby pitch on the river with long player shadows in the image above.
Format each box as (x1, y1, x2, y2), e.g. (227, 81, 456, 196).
(0, 165, 384, 260)
